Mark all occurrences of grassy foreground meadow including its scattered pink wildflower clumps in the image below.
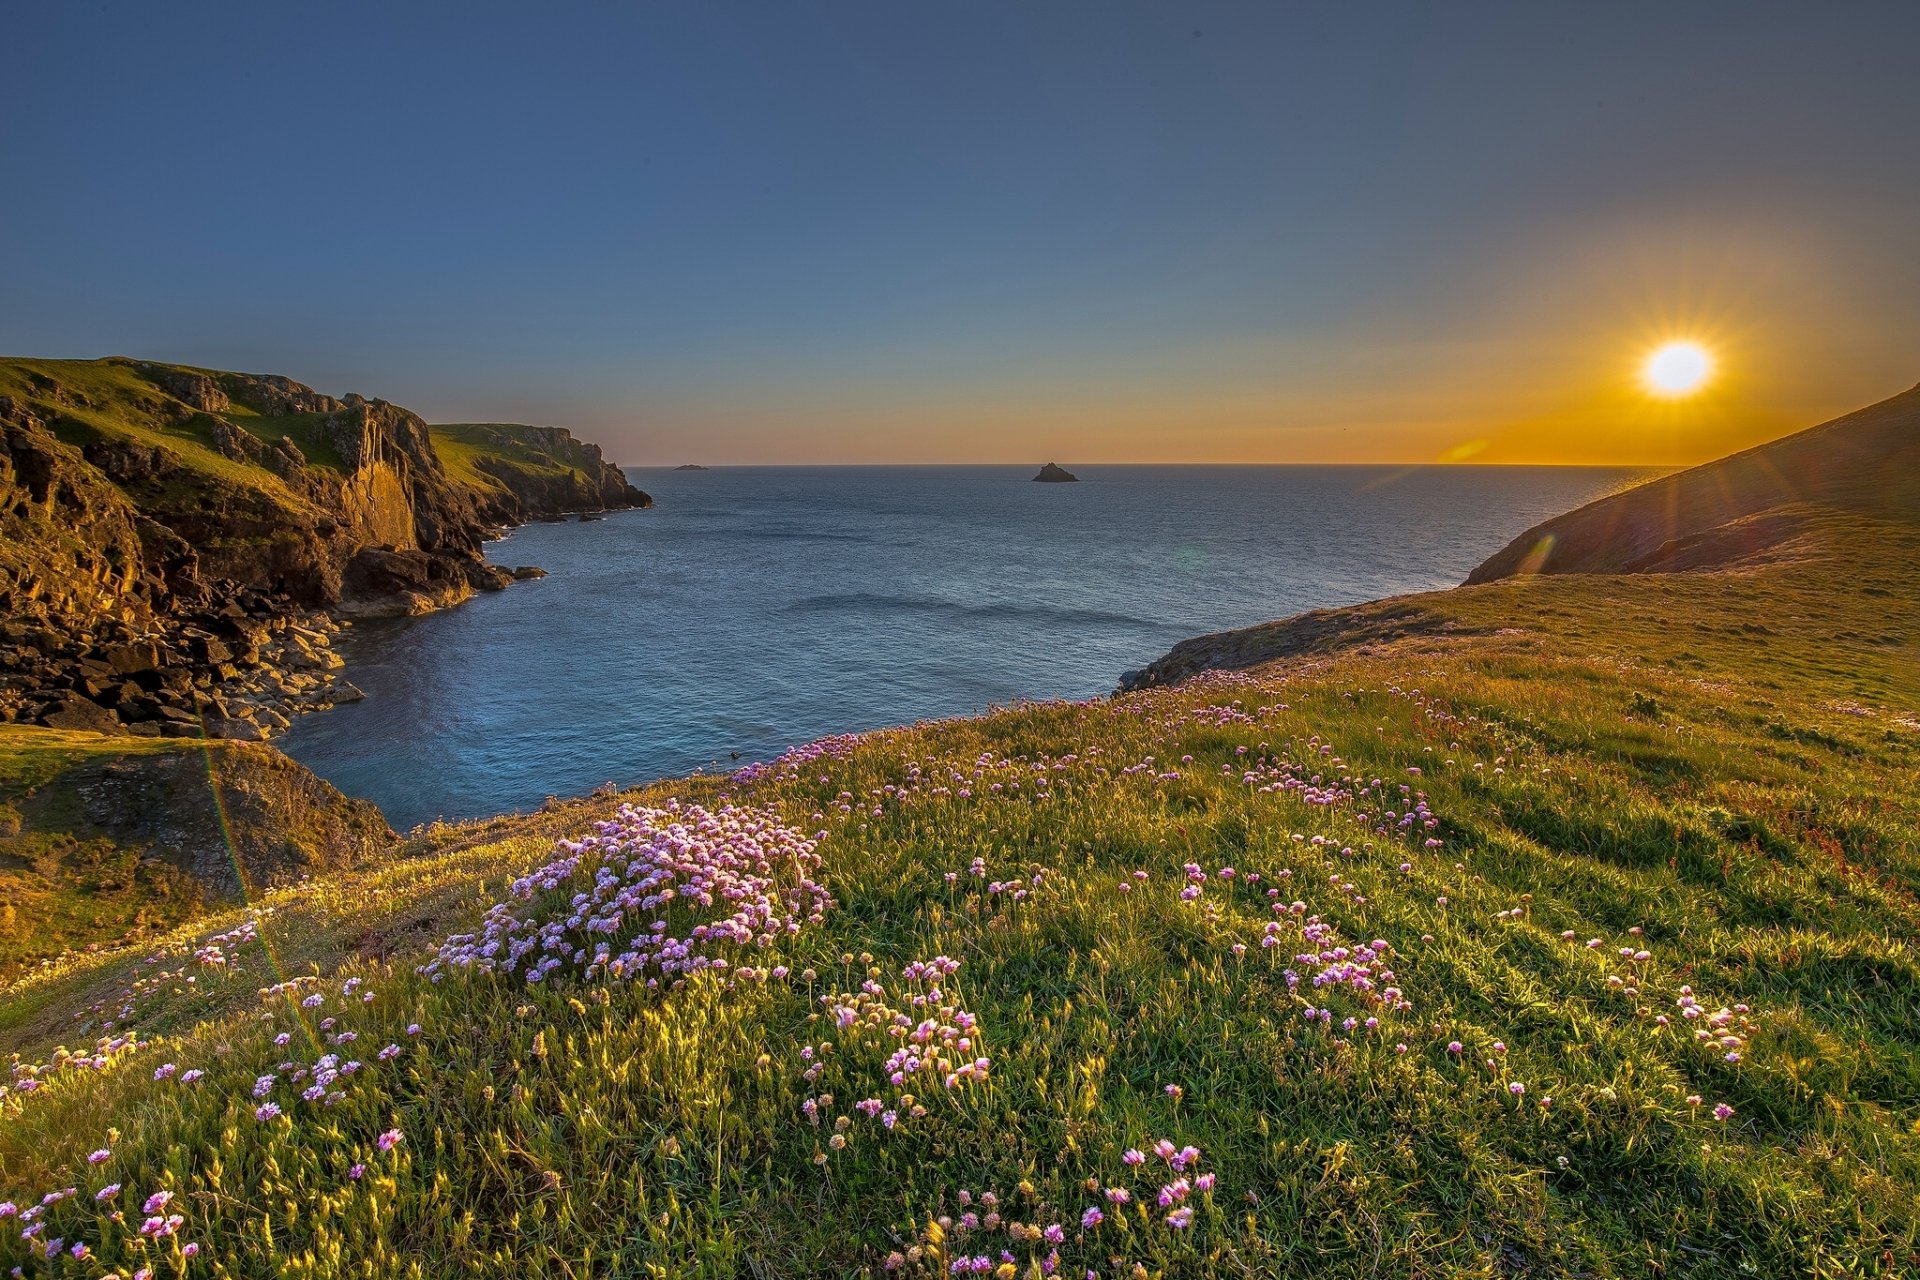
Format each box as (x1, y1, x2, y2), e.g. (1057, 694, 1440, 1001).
(0, 556, 1920, 1280)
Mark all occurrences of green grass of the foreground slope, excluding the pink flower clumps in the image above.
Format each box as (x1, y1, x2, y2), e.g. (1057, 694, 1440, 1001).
(0, 498, 1920, 1276)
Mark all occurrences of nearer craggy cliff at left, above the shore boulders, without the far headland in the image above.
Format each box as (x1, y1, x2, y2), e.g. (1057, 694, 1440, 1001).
(0, 359, 505, 622)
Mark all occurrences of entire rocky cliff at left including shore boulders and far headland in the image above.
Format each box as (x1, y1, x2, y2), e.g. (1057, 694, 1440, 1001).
(0, 357, 647, 737)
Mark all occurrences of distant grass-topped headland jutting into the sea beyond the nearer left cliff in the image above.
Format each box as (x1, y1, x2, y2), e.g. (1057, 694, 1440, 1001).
(432, 422, 653, 524)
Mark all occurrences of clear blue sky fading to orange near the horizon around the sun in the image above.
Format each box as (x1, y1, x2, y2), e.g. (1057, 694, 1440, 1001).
(0, 0, 1920, 464)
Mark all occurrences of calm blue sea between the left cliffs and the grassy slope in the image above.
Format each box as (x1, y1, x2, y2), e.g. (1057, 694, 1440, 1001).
(280, 466, 1636, 827)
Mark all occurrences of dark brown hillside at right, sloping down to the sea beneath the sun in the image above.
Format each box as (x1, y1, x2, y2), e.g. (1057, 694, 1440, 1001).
(1467, 379, 1920, 583)
